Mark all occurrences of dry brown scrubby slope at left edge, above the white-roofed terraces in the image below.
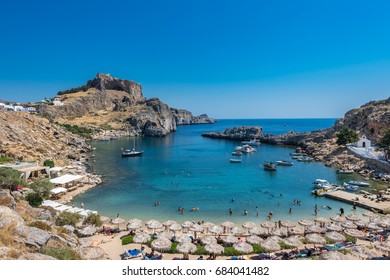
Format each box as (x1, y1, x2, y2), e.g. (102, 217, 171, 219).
(0, 112, 91, 165)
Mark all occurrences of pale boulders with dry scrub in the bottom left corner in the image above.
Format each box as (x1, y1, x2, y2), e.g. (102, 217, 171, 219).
(0, 189, 107, 260)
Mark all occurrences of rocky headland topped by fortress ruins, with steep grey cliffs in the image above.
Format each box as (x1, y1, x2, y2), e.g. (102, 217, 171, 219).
(38, 74, 213, 136)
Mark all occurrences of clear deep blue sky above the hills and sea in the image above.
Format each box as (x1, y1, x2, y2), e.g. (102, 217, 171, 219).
(0, 0, 390, 118)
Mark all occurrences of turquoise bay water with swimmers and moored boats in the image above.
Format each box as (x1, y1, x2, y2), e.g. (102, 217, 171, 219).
(74, 119, 368, 222)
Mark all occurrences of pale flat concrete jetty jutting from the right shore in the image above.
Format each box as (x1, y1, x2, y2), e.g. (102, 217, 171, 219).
(325, 191, 390, 214)
